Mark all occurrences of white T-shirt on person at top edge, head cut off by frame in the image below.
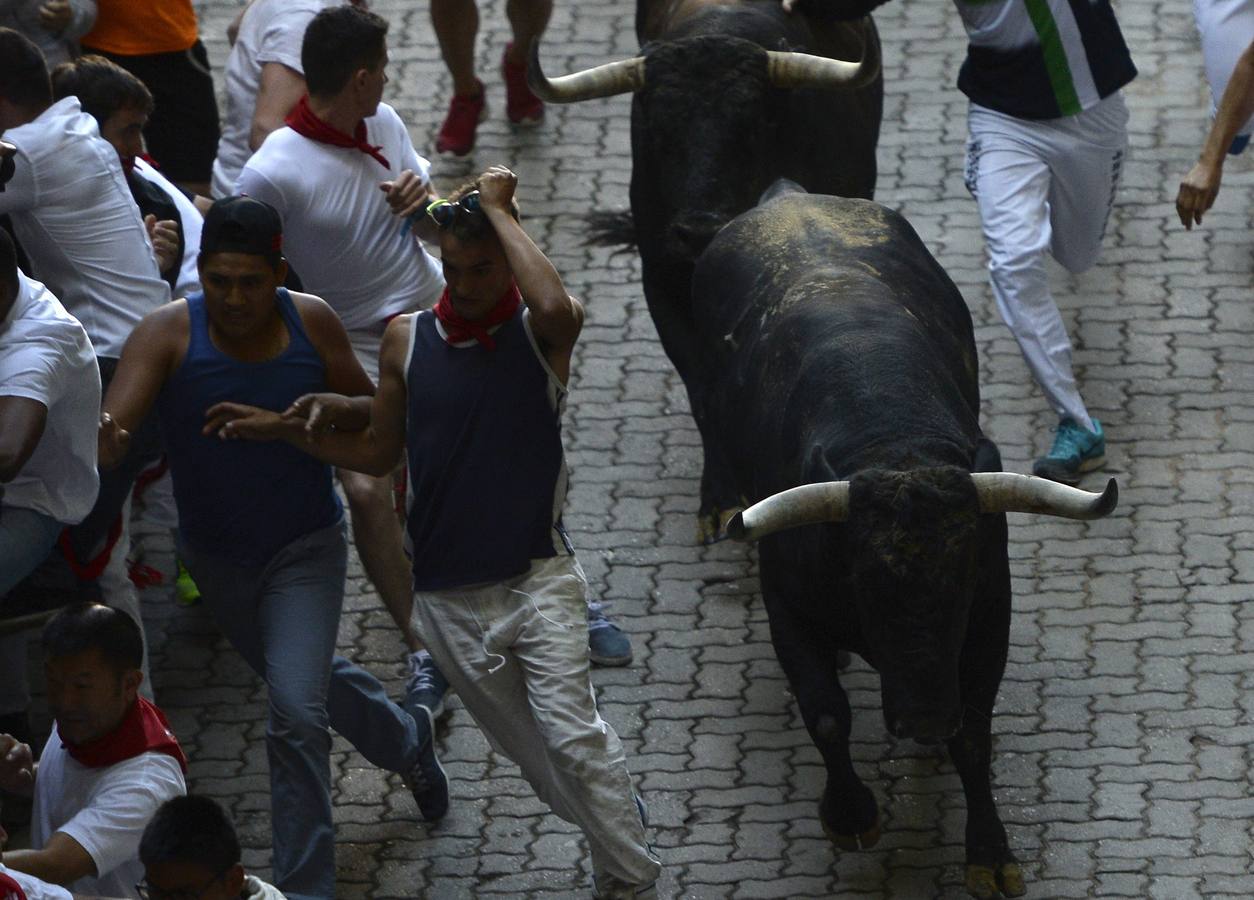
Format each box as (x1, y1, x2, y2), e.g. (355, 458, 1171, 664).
(211, 0, 345, 198)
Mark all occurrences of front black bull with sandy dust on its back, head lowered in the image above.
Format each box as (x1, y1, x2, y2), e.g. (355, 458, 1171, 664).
(692, 188, 1115, 896)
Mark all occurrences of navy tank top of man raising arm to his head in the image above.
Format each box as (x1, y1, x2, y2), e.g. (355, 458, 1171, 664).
(405, 307, 571, 590)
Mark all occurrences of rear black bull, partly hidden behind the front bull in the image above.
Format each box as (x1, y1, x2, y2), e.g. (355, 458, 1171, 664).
(530, 0, 883, 540)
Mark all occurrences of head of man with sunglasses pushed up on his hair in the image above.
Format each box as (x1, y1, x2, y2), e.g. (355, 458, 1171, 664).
(438, 182, 518, 321)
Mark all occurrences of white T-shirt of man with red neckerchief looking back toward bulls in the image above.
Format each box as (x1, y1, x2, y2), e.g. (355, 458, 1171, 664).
(237, 103, 444, 331)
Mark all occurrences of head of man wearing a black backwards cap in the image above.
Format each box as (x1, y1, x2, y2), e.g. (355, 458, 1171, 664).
(197, 197, 287, 338)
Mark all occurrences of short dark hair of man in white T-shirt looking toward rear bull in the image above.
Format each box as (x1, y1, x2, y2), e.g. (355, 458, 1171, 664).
(301, 6, 387, 97)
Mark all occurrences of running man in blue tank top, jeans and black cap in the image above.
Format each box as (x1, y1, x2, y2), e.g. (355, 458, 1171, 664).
(99, 197, 448, 900)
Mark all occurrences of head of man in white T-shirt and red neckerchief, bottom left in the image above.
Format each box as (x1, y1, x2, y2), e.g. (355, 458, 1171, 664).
(43, 603, 144, 743)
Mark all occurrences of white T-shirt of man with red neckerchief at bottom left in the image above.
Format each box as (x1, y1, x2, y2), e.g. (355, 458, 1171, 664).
(30, 731, 187, 897)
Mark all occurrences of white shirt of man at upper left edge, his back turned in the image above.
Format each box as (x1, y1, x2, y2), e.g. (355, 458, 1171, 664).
(0, 97, 169, 358)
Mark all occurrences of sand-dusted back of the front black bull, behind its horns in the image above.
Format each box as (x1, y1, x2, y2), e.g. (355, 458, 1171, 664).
(692, 193, 979, 493)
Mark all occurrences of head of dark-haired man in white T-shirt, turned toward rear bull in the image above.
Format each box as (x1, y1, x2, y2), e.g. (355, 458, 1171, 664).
(301, 6, 387, 109)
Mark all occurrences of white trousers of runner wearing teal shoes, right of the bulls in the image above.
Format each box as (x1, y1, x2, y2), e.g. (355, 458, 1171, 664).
(964, 93, 1127, 431)
